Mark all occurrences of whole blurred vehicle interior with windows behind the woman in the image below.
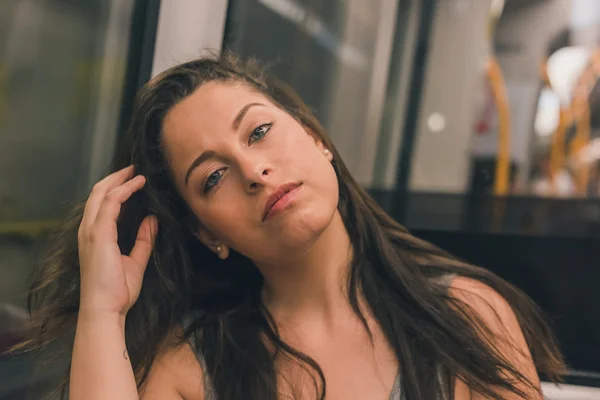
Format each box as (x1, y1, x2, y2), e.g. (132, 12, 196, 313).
(0, 0, 600, 399)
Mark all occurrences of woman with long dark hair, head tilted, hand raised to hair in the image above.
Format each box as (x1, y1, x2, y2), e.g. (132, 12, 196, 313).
(16, 54, 564, 400)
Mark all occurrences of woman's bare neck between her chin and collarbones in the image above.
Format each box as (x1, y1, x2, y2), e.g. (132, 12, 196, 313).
(259, 211, 352, 324)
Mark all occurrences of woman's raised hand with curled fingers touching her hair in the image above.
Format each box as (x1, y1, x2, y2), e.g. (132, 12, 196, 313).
(78, 166, 158, 316)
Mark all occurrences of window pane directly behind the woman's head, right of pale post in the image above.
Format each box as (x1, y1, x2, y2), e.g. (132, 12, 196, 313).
(225, 0, 404, 186)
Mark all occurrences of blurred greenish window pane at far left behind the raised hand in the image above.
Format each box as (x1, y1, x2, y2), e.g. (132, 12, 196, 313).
(0, 0, 133, 399)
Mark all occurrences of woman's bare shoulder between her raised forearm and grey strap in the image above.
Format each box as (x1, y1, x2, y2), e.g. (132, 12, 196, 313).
(140, 332, 204, 400)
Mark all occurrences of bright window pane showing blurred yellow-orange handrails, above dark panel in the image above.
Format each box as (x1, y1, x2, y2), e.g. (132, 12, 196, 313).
(409, 0, 600, 198)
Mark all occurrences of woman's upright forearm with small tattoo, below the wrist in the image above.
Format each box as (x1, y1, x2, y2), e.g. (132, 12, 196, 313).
(69, 311, 139, 400)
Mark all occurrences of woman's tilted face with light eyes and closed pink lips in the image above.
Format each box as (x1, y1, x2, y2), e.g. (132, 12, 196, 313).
(163, 82, 338, 262)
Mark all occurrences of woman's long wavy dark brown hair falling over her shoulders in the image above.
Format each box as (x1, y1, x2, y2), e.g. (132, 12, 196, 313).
(11, 53, 565, 400)
